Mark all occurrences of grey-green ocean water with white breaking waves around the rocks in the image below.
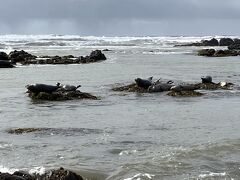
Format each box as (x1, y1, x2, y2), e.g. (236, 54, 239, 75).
(0, 35, 240, 180)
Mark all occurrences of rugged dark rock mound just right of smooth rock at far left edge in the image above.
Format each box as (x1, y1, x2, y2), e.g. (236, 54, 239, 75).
(9, 50, 37, 63)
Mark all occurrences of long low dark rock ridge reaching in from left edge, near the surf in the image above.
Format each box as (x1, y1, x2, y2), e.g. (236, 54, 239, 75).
(0, 50, 107, 67)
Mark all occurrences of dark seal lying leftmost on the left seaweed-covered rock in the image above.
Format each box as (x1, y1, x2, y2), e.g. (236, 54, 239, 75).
(26, 84, 59, 93)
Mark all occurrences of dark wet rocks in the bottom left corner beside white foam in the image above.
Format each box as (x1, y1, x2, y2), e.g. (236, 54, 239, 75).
(0, 167, 83, 180)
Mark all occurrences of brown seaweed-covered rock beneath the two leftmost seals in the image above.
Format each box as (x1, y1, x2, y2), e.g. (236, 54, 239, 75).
(29, 90, 98, 101)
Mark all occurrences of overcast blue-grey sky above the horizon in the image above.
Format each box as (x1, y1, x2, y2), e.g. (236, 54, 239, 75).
(0, 0, 240, 36)
